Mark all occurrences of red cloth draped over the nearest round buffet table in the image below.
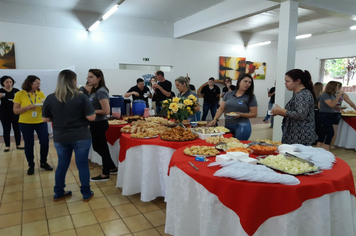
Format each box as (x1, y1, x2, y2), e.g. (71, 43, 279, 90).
(169, 145, 355, 235)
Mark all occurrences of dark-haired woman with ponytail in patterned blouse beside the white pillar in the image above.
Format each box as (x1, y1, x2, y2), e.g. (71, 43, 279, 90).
(271, 69, 317, 145)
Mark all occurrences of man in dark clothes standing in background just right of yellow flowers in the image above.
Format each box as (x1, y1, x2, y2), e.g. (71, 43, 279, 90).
(200, 77, 220, 120)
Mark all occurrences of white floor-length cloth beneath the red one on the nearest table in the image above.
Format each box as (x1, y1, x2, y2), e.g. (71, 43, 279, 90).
(165, 167, 356, 236)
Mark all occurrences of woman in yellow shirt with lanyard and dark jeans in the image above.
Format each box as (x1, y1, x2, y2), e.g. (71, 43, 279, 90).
(13, 75, 53, 175)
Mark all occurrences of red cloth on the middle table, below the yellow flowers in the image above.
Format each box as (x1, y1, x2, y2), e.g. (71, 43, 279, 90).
(119, 133, 232, 162)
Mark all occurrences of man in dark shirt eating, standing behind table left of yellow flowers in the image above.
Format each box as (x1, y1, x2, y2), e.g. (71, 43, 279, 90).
(152, 70, 172, 114)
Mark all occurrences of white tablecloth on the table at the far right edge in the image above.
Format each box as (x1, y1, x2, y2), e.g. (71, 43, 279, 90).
(335, 119, 356, 150)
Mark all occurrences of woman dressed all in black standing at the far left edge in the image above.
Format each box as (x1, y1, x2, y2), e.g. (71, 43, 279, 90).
(0, 75, 23, 152)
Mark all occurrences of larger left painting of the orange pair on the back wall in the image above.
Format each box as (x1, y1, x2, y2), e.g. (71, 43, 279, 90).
(219, 57, 246, 80)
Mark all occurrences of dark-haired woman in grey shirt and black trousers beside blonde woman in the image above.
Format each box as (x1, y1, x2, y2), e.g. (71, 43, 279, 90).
(88, 69, 117, 182)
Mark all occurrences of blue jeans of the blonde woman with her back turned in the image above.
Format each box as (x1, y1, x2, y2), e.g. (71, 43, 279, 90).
(54, 139, 91, 196)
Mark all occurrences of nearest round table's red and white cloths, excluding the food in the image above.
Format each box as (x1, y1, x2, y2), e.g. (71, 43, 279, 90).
(165, 145, 356, 236)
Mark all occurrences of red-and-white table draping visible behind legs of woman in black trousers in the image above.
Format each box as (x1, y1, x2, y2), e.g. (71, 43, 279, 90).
(89, 124, 126, 166)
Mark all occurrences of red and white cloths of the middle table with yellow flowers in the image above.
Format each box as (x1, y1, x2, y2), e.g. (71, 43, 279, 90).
(116, 133, 232, 202)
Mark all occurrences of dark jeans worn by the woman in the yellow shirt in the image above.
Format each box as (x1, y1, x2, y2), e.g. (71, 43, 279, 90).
(19, 122, 49, 167)
